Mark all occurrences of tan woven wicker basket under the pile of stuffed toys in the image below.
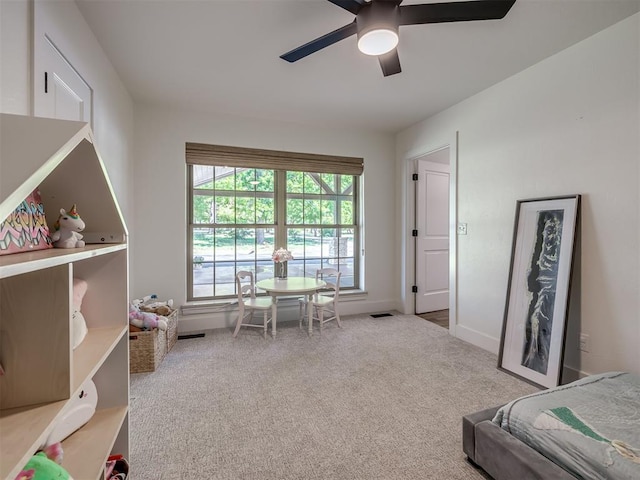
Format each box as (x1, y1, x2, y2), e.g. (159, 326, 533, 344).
(129, 310, 178, 373)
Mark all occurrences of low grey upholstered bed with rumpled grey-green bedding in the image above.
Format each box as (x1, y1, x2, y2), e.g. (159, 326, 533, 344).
(462, 372, 640, 480)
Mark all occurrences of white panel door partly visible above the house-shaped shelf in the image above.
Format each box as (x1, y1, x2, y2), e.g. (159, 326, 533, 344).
(34, 35, 93, 123)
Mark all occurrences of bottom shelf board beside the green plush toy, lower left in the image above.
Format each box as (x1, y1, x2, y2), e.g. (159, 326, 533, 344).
(62, 406, 128, 480)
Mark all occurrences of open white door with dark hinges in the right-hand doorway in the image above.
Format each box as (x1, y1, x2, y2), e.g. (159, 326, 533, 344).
(416, 154, 449, 314)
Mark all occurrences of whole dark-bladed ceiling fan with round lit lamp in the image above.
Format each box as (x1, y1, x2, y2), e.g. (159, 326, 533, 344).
(280, 0, 516, 77)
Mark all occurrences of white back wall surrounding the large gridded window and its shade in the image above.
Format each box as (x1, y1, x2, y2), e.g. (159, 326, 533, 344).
(131, 105, 398, 332)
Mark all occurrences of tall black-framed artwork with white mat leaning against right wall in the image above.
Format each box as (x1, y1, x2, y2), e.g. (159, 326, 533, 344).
(498, 195, 580, 388)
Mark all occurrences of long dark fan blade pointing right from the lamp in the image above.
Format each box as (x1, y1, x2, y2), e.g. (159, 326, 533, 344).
(399, 0, 516, 25)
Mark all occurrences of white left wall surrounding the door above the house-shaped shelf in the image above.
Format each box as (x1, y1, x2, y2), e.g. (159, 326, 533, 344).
(0, 0, 133, 229)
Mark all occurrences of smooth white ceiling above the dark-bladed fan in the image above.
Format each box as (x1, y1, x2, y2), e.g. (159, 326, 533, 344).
(76, 0, 640, 133)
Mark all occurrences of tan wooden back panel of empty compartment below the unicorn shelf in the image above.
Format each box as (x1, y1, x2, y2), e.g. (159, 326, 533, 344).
(0, 265, 71, 410)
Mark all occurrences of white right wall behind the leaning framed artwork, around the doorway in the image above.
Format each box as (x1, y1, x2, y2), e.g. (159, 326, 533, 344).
(397, 14, 640, 373)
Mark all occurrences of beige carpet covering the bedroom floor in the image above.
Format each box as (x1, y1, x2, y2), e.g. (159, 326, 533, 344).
(130, 315, 536, 480)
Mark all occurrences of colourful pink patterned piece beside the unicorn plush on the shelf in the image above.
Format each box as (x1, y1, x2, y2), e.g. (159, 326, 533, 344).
(0, 189, 53, 255)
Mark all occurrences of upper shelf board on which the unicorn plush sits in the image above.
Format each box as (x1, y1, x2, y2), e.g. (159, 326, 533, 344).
(0, 243, 127, 278)
